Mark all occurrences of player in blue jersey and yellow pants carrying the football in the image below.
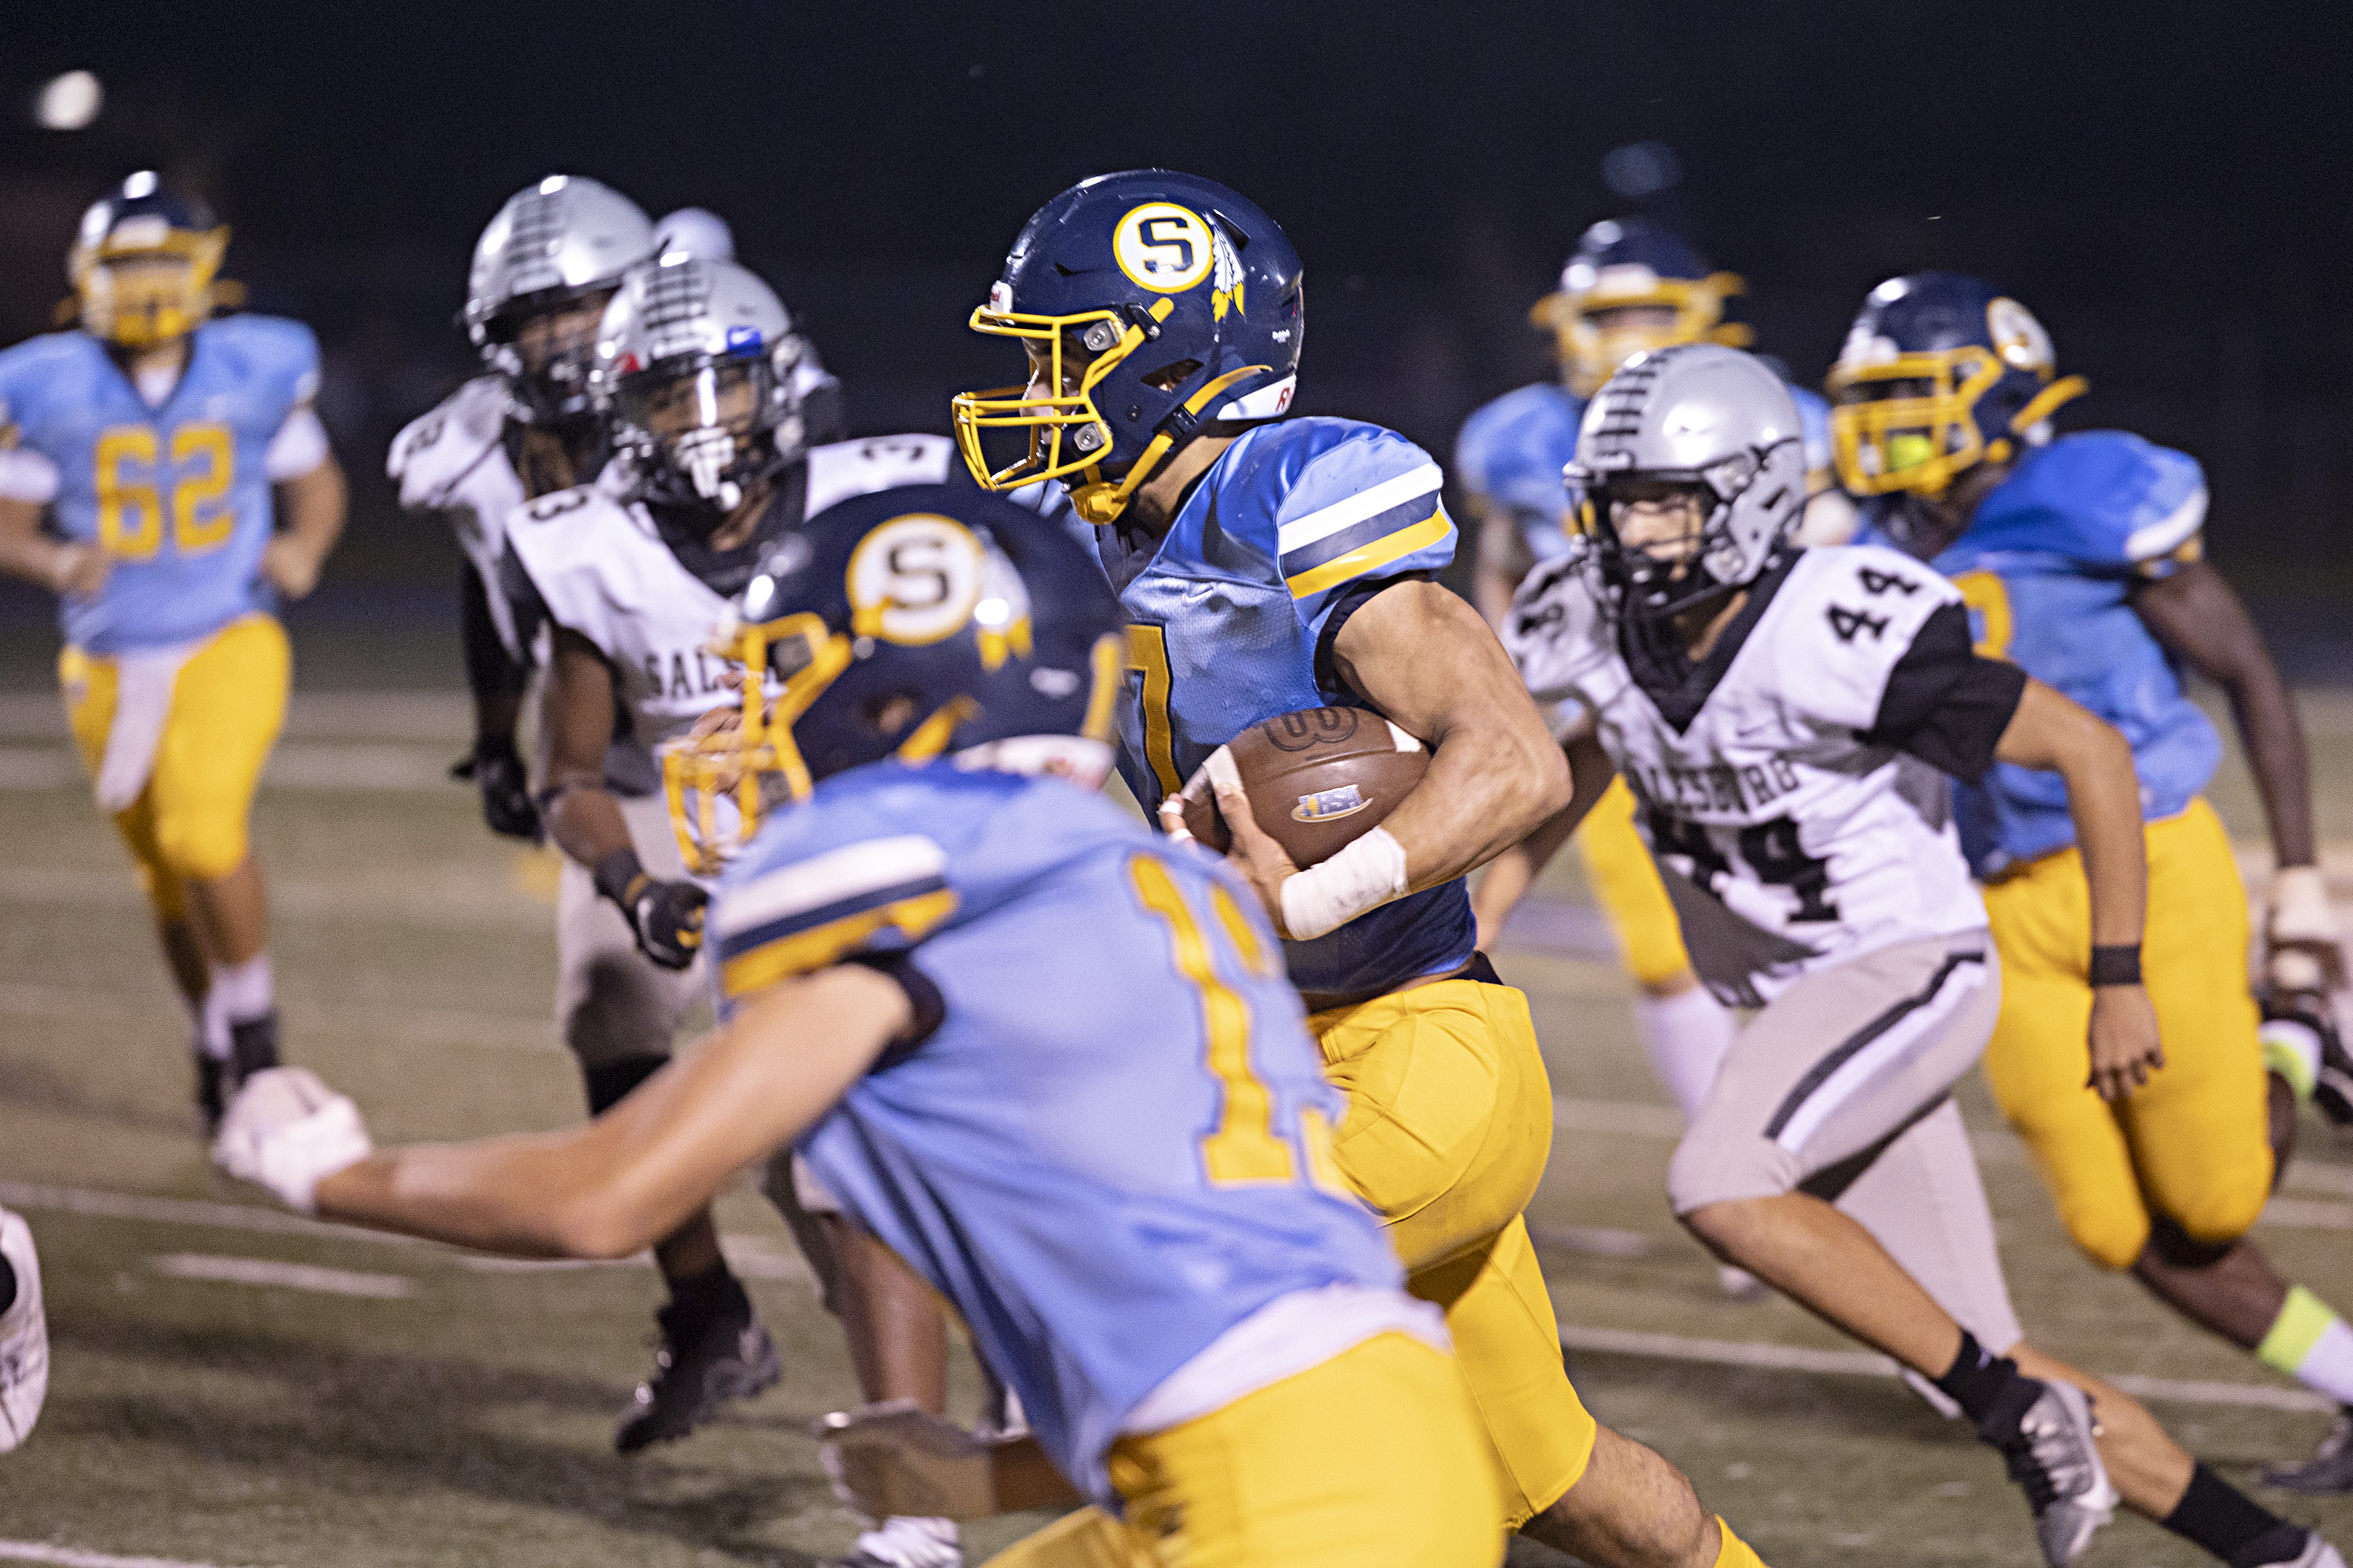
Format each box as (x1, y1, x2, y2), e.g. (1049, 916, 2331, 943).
(953, 169, 1753, 1568)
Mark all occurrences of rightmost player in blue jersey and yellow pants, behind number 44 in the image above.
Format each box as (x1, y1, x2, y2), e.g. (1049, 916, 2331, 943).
(1831, 273, 2353, 1491)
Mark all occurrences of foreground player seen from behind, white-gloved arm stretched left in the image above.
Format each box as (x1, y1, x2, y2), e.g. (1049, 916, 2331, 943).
(221, 487, 1502, 1568)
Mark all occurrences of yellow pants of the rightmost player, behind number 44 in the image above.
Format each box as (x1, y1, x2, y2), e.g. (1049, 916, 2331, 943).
(1986, 799, 2271, 1269)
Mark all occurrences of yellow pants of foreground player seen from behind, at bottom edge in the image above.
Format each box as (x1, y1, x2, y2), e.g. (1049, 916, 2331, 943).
(988, 1333, 1504, 1568)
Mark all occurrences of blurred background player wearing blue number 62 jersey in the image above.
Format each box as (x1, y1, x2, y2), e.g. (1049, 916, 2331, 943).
(0, 169, 343, 1126)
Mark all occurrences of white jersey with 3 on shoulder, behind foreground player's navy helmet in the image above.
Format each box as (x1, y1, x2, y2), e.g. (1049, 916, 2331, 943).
(506, 435, 955, 778)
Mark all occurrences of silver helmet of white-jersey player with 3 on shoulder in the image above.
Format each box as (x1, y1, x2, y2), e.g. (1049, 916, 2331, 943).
(588, 252, 809, 513)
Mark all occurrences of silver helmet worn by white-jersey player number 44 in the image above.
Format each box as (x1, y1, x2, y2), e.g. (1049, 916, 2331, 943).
(1562, 343, 1805, 616)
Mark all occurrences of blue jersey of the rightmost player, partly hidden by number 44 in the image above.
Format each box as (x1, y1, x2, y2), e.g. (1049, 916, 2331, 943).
(1854, 430, 2221, 877)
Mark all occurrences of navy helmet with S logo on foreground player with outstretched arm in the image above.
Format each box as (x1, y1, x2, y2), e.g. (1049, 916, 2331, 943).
(661, 484, 1125, 872)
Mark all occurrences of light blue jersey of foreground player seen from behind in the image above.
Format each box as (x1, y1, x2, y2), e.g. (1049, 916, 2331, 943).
(708, 761, 1400, 1502)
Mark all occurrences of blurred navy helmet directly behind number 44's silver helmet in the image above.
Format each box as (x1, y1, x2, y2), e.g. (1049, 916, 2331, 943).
(1530, 218, 1750, 397)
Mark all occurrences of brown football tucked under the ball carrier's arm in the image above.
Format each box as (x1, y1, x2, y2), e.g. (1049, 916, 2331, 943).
(1184, 708, 1431, 868)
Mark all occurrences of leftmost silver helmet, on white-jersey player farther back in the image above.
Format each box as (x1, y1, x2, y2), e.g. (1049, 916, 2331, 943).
(464, 174, 654, 421)
